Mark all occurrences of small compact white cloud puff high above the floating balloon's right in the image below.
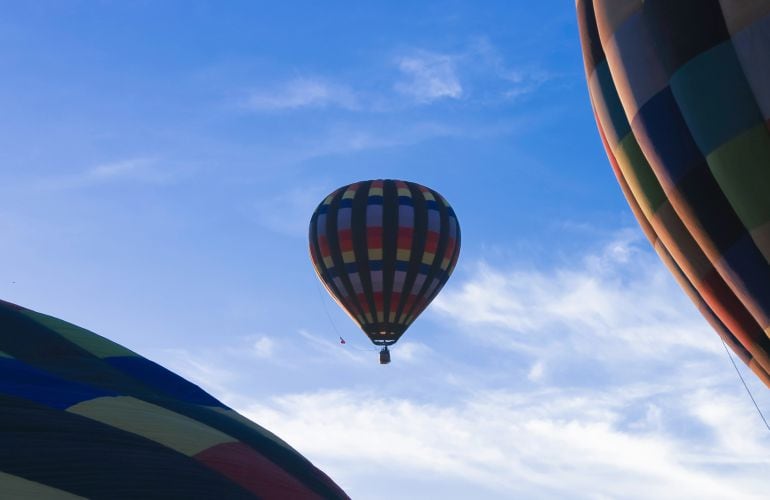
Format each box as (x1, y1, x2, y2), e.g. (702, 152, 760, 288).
(395, 51, 463, 103)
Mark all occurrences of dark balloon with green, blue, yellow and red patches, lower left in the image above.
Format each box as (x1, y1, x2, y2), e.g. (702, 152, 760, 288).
(0, 301, 348, 499)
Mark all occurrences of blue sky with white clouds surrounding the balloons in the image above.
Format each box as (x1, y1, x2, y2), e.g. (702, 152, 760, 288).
(0, 0, 770, 499)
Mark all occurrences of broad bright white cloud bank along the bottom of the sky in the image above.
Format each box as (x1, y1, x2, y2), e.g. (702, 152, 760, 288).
(242, 387, 770, 499)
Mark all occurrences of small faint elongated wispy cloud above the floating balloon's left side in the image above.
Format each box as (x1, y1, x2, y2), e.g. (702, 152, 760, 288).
(244, 77, 359, 111)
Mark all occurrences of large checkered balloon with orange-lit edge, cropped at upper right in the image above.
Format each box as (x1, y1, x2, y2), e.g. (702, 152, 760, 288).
(577, 0, 770, 386)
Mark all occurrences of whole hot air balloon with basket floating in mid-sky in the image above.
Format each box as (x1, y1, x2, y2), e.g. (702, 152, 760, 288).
(310, 179, 460, 364)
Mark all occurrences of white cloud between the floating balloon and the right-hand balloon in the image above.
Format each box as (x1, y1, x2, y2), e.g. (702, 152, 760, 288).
(433, 232, 720, 357)
